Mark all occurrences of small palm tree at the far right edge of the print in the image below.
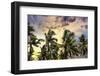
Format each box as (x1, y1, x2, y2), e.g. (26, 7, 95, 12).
(79, 34, 88, 56)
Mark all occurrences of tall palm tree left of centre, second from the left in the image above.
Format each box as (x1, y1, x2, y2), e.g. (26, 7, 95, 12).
(41, 29, 58, 60)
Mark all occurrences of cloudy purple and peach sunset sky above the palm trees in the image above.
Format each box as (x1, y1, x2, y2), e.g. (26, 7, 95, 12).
(28, 15, 88, 43)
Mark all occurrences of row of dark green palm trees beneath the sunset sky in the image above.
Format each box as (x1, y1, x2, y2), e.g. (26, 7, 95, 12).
(28, 26, 88, 61)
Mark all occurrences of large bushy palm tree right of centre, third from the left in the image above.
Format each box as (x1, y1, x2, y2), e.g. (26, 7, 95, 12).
(62, 30, 79, 59)
